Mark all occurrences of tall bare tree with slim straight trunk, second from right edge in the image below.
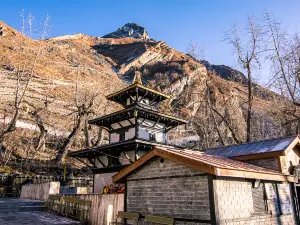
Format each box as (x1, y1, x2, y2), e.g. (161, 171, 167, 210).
(225, 17, 262, 142)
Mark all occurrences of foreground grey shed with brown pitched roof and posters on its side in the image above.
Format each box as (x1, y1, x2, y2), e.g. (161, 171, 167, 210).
(113, 147, 296, 225)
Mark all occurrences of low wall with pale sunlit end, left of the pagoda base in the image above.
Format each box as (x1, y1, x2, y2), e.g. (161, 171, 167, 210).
(20, 182, 60, 201)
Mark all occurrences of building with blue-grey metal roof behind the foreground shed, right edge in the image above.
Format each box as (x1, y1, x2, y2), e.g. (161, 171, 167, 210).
(205, 136, 300, 174)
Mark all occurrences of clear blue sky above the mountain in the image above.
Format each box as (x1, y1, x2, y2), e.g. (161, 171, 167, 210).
(0, 0, 300, 83)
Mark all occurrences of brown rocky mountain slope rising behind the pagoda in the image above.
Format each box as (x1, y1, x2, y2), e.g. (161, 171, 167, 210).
(0, 22, 290, 174)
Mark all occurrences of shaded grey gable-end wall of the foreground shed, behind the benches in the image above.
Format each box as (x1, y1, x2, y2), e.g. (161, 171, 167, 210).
(127, 158, 210, 224)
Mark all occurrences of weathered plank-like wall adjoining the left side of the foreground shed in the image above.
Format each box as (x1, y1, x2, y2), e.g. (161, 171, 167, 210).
(63, 194, 124, 225)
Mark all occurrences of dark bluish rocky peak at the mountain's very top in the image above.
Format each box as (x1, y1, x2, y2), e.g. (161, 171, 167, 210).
(103, 23, 149, 39)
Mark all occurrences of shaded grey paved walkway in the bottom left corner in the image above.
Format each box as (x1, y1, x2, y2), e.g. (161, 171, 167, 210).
(0, 212, 82, 225)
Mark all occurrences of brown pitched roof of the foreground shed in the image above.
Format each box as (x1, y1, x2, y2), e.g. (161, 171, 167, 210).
(113, 147, 294, 182)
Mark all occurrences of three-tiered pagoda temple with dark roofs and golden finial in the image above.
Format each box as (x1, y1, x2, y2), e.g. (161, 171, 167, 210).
(68, 73, 187, 192)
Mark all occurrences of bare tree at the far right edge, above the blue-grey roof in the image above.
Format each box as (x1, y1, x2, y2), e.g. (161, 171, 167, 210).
(264, 10, 300, 135)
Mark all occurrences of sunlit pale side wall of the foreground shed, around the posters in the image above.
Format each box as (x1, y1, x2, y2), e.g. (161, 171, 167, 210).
(213, 178, 296, 225)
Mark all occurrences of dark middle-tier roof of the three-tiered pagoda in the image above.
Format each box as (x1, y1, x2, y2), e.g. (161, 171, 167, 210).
(89, 105, 187, 130)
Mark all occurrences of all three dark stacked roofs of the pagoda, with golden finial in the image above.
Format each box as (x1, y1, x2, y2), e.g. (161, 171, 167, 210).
(68, 74, 187, 173)
